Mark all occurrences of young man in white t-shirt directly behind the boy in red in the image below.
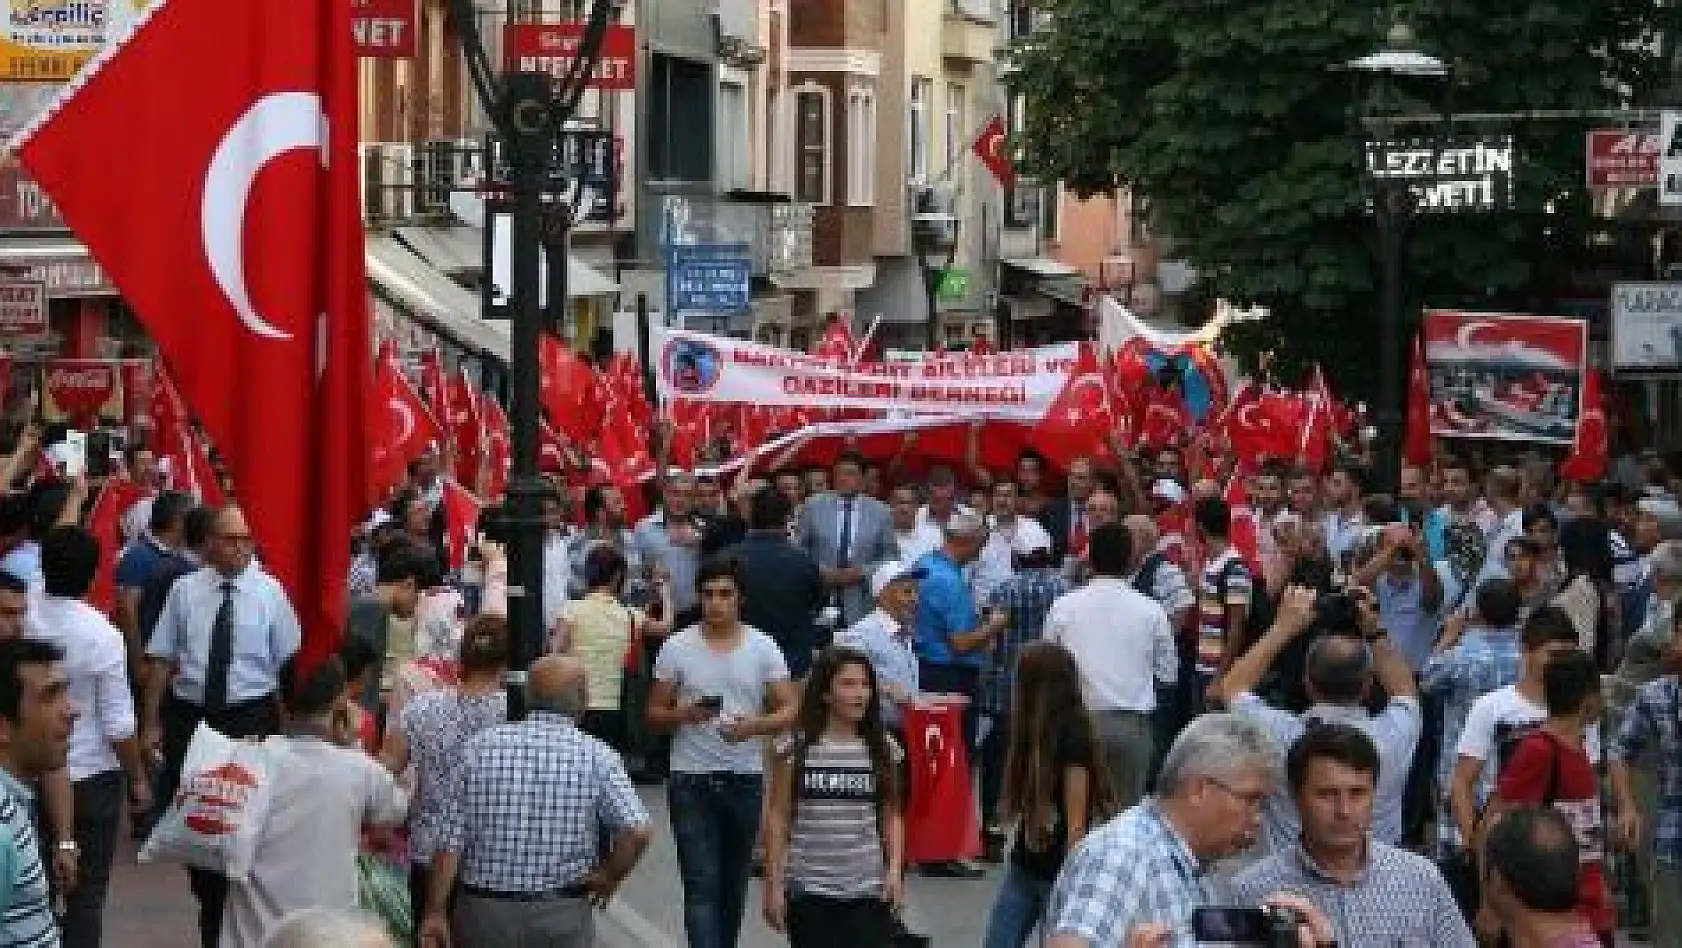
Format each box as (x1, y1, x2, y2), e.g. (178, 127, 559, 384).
(1448, 605, 1600, 840)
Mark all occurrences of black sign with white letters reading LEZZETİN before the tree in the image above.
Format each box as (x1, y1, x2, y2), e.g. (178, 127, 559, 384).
(1366, 134, 1514, 213)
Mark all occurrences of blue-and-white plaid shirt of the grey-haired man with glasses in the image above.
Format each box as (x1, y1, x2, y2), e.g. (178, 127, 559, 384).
(1041, 798, 1219, 948)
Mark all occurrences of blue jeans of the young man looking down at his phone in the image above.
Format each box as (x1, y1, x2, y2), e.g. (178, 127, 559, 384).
(668, 773, 765, 948)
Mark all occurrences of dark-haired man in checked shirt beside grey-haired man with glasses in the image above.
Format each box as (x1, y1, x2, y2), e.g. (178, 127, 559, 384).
(1233, 723, 1477, 948)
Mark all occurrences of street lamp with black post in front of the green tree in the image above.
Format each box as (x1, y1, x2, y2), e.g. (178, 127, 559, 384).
(1346, 24, 1448, 489)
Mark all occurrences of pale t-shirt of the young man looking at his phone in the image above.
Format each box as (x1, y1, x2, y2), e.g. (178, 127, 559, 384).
(654, 625, 789, 773)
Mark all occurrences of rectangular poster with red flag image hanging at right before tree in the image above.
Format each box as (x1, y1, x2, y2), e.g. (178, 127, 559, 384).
(1423, 309, 1588, 445)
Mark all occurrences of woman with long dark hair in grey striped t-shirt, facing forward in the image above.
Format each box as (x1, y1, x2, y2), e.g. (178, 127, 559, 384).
(765, 645, 905, 948)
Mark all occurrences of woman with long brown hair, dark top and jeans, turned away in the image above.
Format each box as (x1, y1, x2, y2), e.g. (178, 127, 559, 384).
(984, 642, 1115, 948)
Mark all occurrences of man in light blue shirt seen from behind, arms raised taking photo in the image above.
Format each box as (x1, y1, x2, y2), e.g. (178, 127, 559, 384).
(1214, 587, 1423, 852)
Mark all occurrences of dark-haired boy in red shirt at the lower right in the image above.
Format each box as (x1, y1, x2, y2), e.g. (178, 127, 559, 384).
(1478, 649, 1618, 946)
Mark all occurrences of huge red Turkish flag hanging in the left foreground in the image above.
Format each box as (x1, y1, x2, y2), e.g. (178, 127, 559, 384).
(12, 0, 373, 662)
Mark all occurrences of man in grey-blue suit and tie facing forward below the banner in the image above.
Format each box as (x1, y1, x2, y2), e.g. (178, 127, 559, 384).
(794, 450, 900, 629)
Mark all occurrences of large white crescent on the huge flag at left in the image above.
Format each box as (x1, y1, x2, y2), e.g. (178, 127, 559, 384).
(200, 92, 328, 340)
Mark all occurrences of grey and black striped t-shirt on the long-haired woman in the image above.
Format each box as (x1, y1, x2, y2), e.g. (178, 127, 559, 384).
(785, 740, 898, 899)
